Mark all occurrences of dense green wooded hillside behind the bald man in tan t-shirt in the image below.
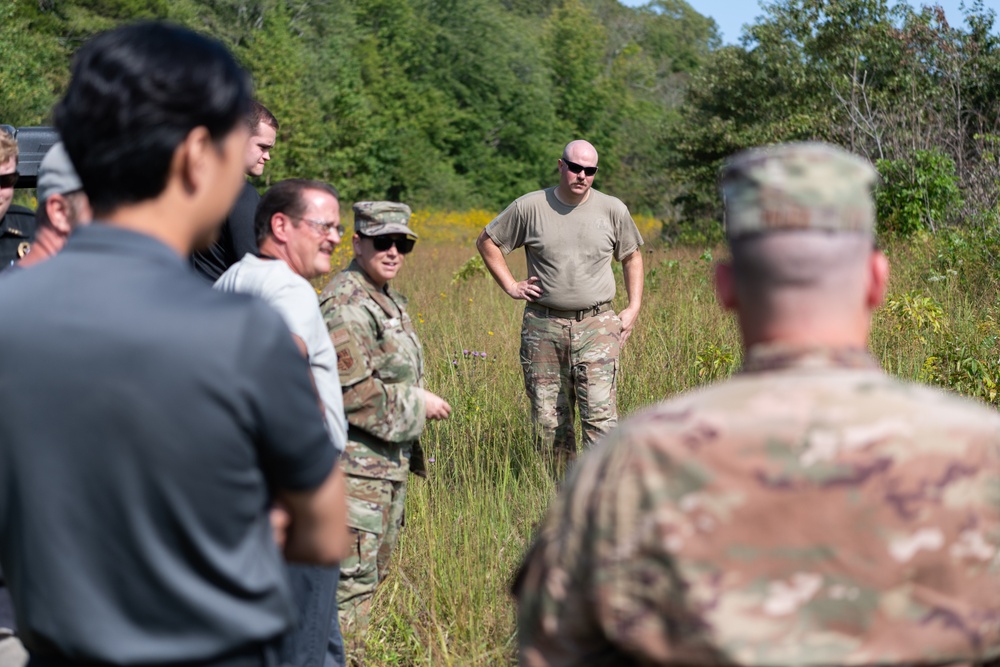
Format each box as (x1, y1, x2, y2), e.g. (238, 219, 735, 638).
(0, 0, 718, 215)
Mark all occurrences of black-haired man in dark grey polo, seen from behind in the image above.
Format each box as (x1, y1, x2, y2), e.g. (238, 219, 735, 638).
(0, 24, 346, 667)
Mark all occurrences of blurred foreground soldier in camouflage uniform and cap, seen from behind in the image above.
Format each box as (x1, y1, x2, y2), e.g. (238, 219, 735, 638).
(515, 144, 1000, 667)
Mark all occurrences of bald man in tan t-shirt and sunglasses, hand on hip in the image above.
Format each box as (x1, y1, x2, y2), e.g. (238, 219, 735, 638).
(476, 140, 643, 470)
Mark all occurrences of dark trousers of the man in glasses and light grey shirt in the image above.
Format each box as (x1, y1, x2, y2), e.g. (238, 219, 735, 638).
(279, 564, 344, 667)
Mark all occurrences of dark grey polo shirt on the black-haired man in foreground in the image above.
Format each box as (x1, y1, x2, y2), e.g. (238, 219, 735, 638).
(0, 224, 336, 664)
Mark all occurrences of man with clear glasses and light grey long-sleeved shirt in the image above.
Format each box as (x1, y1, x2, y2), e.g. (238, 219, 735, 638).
(215, 179, 347, 667)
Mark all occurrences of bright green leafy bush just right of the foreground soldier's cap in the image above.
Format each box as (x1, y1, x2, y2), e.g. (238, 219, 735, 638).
(875, 150, 962, 236)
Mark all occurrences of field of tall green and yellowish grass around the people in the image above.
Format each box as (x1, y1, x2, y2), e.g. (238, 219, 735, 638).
(316, 212, 1000, 665)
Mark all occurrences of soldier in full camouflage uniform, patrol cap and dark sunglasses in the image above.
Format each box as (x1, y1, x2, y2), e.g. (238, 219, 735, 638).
(320, 201, 451, 664)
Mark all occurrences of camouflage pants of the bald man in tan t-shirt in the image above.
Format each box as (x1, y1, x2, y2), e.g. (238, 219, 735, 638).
(521, 308, 622, 462)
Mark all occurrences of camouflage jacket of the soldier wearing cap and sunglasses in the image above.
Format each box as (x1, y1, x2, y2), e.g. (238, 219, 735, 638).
(319, 261, 426, 480)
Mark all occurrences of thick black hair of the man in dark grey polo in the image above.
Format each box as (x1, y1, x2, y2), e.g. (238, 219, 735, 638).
(53, 23, 250, 215)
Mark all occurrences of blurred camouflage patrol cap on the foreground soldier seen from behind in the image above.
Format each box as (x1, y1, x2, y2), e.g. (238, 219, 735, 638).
(721, 143, 878, 239)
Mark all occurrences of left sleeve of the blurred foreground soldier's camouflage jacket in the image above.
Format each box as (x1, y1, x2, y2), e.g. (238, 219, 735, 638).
(514, 433, 724, 667)
